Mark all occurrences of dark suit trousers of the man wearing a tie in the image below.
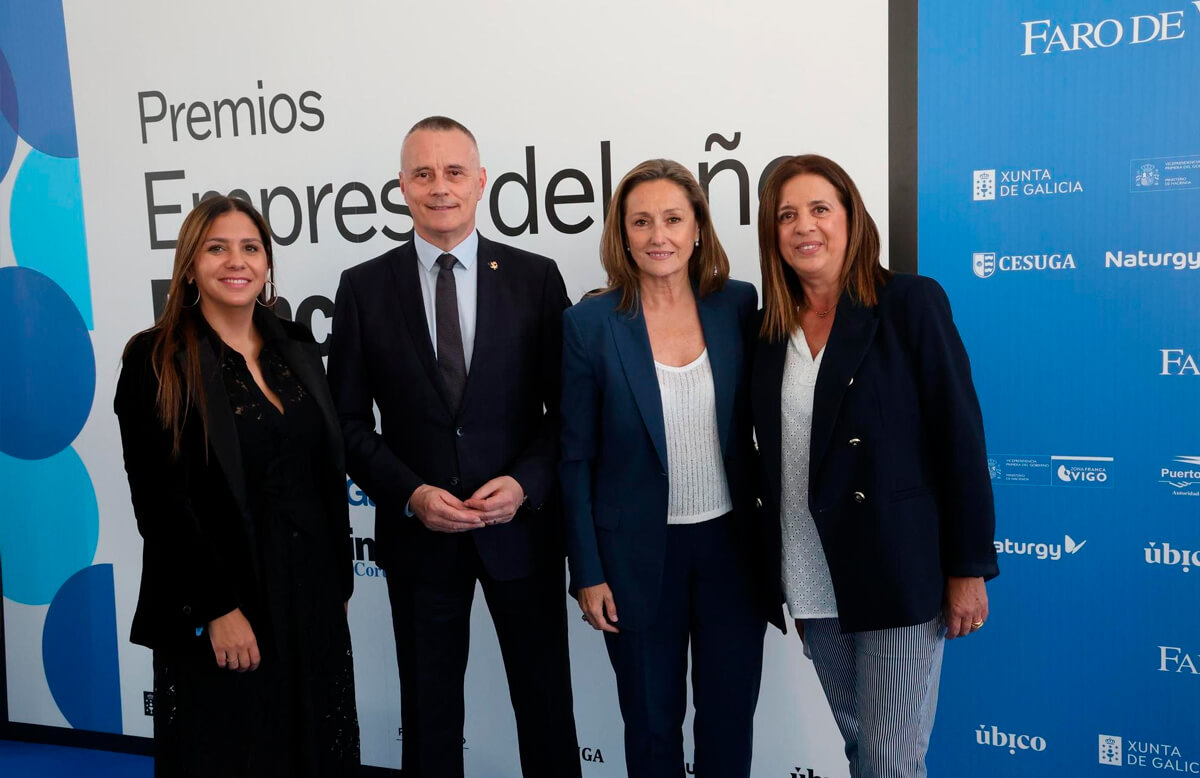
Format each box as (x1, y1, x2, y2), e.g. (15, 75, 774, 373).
(388, 534, 580, 778)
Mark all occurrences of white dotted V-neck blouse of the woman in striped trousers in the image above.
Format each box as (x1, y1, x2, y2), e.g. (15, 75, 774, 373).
(780, 330, 838, 618)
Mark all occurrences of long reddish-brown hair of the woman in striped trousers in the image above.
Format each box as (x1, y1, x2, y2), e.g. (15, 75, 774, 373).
(758, 154, 889, 341)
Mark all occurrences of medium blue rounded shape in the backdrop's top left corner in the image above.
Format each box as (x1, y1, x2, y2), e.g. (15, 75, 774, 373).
(0, 0, 79, 157)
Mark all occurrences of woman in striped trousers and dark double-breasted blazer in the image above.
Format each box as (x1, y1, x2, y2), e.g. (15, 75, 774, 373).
(751, 155, 997, 777)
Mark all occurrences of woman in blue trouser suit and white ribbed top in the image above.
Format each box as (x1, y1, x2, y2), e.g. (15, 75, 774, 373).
(560, 160, 766, 778)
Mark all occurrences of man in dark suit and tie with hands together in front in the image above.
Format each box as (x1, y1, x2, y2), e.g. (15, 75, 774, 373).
(329, 116, 580, 778)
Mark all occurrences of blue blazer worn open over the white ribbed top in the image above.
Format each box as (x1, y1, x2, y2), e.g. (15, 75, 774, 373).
(559, 281, 761, 629)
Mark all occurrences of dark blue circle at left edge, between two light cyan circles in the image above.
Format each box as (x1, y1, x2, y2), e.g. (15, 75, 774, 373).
(0, 268, 96, 461)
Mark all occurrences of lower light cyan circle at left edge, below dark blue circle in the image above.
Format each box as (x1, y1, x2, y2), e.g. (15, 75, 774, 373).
(0, 448, 100, 605)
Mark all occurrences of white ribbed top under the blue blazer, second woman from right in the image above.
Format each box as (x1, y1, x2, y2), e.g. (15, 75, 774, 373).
(654, 348, 733, 523)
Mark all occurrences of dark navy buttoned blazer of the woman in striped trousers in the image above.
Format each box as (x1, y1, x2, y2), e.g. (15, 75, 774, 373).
(751, 275, 998, 632)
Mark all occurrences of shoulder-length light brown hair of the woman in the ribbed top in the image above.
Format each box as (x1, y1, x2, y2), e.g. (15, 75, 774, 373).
(600, 160, 730, 313)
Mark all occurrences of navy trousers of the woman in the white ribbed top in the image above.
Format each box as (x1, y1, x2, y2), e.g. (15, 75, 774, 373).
(605, 514, 767, 778)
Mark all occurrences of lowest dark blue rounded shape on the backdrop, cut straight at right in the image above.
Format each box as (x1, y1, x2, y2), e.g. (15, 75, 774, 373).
(42, 564, 121, 734)
